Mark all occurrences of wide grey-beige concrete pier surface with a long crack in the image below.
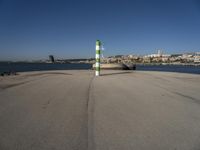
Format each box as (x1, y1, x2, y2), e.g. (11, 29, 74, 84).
(0, 70, 200, 150)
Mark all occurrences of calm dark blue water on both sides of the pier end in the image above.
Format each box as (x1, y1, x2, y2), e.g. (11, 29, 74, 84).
(0, 63, 200, 74)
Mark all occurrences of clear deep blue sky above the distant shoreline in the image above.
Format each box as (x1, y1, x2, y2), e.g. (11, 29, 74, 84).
(0, 0, 200, 60)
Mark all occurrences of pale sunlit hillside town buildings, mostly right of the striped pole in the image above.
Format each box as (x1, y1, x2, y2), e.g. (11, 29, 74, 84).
(82, 50, 200, 65)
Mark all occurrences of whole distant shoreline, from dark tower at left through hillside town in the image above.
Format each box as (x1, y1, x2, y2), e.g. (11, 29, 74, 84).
(37, 50, 200, 66)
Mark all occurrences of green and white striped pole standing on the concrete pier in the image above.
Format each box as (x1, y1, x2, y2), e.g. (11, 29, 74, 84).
(95, 40, 101, 76)
